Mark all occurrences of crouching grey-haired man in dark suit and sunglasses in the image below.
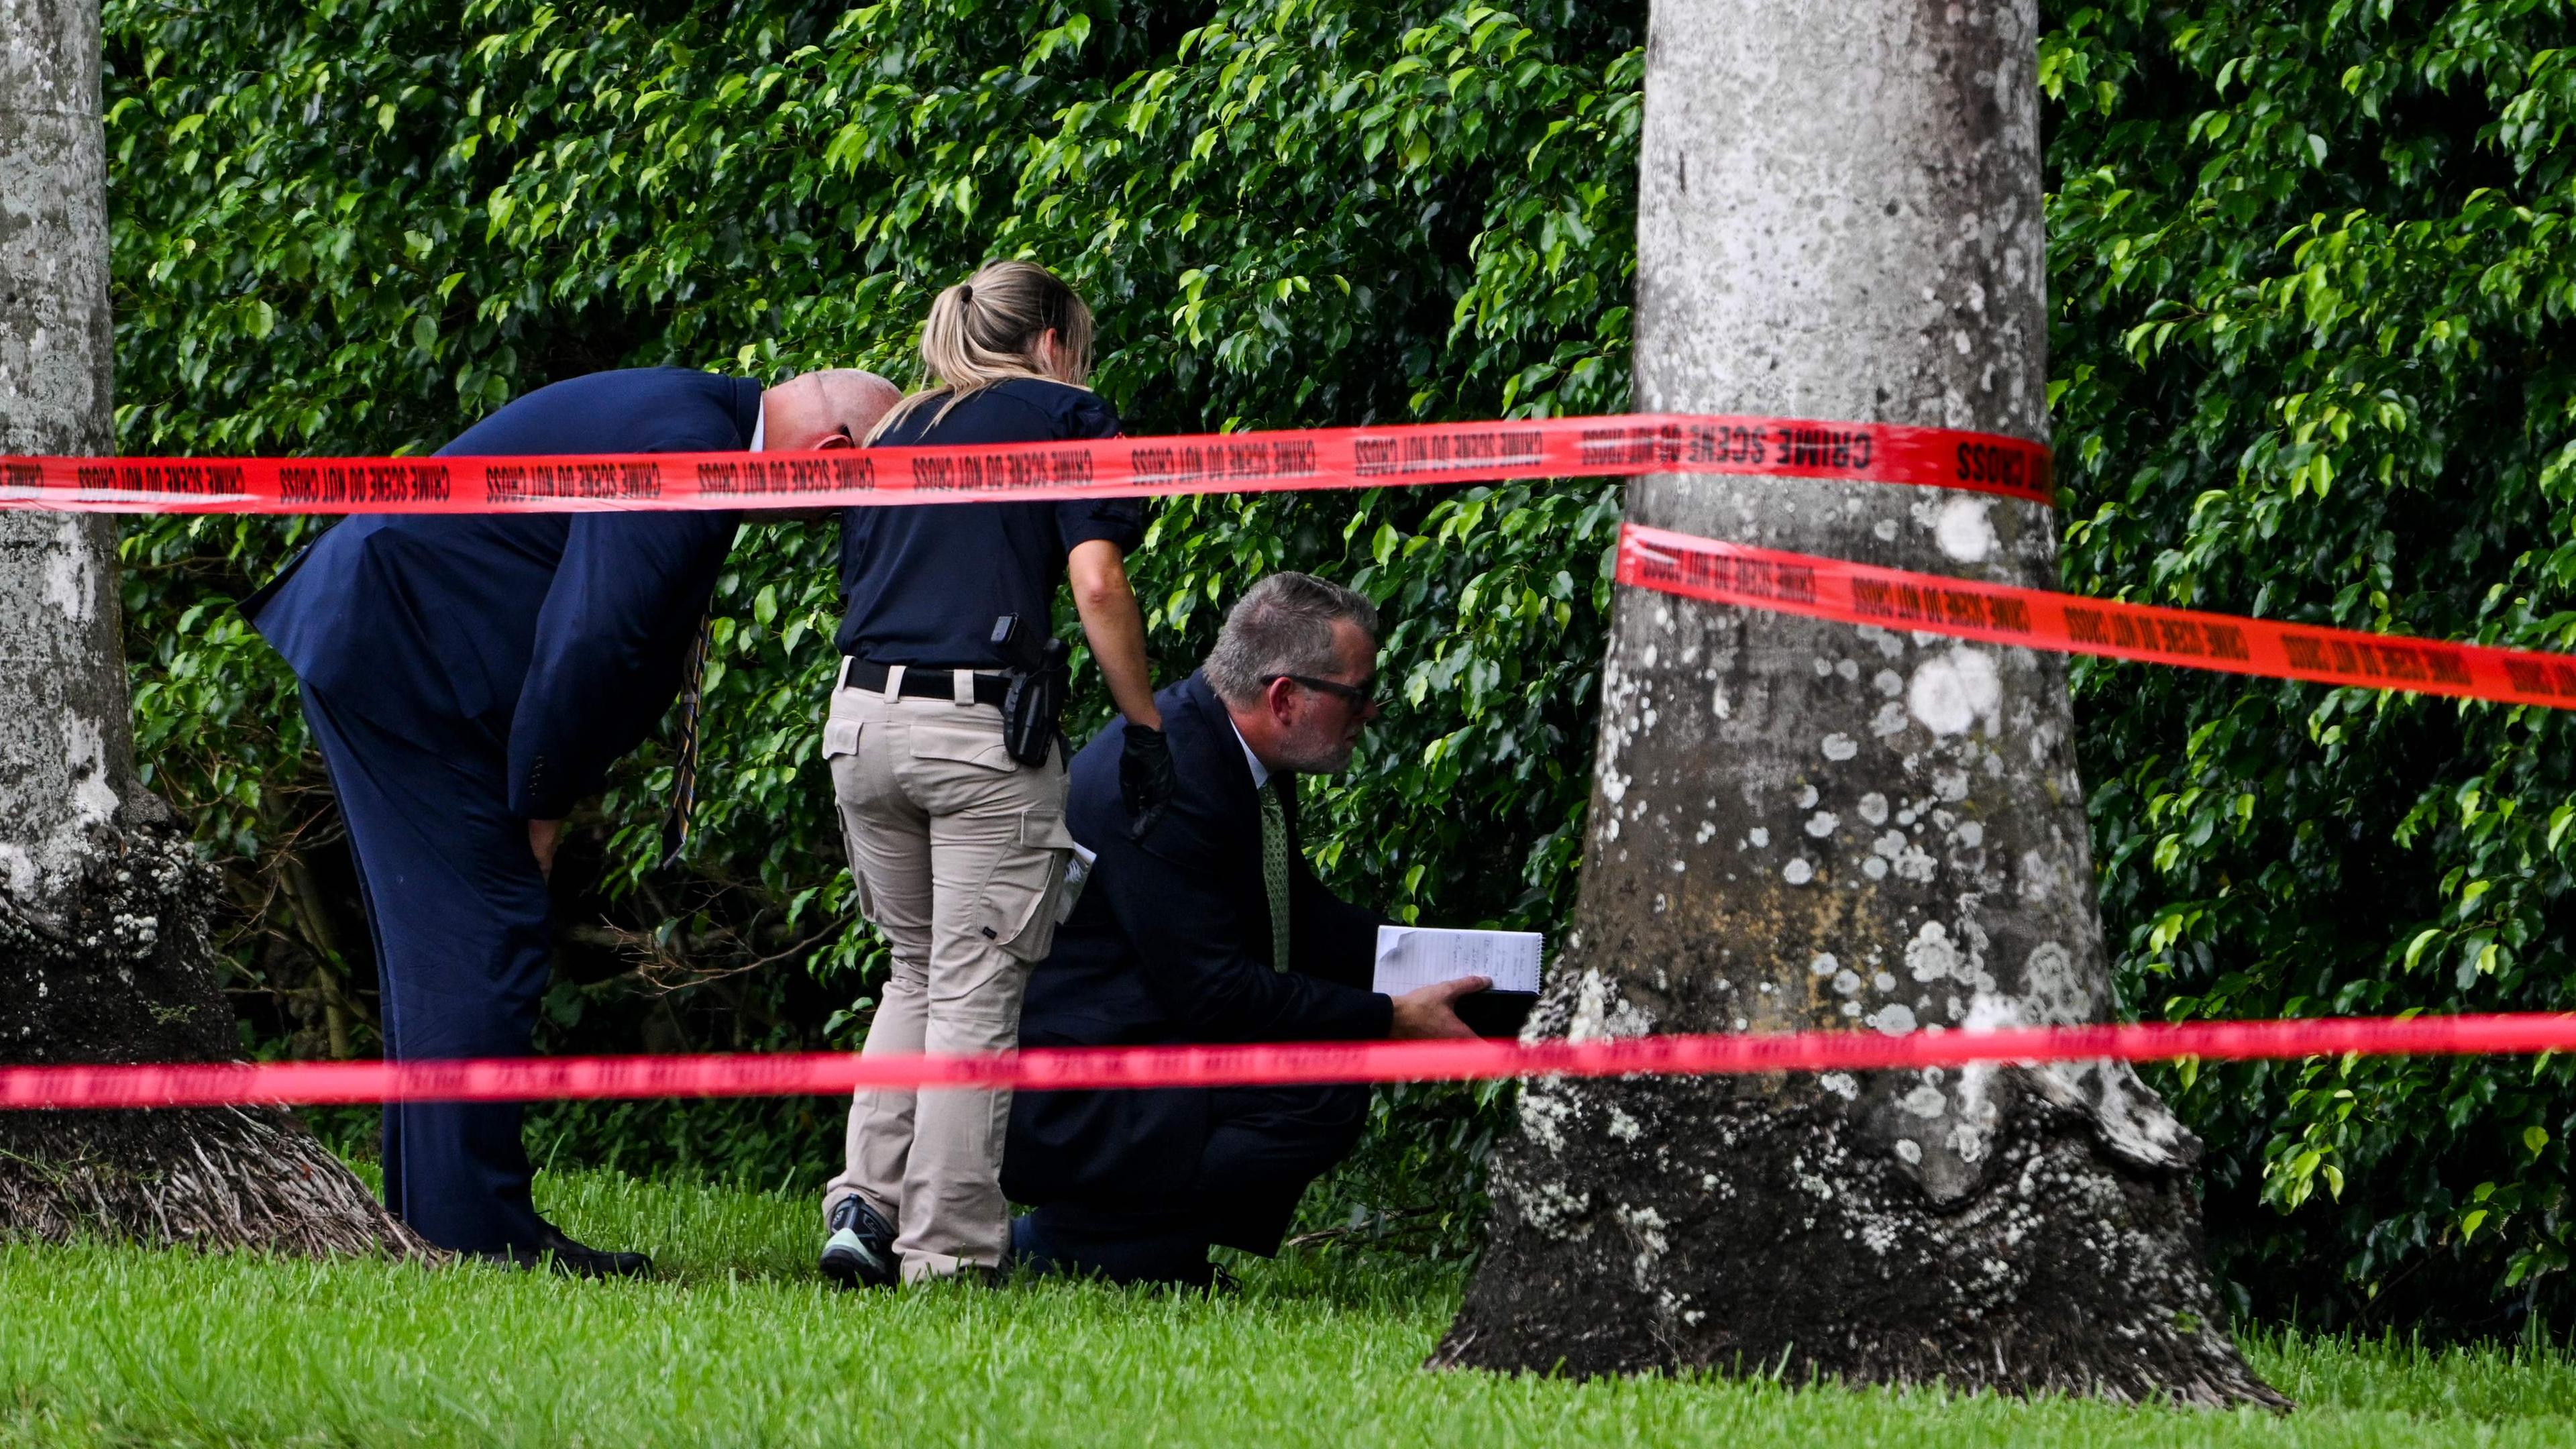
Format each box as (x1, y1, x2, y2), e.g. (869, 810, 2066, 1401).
(1002, 572, 1489, 1284)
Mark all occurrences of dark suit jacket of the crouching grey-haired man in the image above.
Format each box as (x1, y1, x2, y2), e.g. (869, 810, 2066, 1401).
(1002, 673, 1393, 1201)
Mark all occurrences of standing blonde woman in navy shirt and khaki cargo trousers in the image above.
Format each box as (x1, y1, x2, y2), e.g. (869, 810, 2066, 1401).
(822, 260, 1175, 1287)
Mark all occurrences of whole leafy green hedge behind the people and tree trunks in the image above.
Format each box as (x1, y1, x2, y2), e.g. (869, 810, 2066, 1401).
(108, 0, 2576, 1328)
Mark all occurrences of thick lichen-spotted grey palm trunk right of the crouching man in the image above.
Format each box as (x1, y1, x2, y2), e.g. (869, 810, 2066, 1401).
(1432, 0, 2279, 1405)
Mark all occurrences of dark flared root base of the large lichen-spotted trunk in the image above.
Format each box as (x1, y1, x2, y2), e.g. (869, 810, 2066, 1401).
(1427, 1080, 2290, 1408)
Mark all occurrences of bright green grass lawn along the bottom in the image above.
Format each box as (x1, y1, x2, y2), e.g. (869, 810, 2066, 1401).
(0, 1173, 2576, 1449)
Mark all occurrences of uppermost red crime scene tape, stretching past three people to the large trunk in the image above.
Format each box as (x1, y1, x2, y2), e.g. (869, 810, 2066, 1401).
(0, 413, 2055, 513)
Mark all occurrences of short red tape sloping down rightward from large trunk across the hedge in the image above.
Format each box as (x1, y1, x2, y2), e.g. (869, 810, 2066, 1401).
(1618, 523, 2576, 709)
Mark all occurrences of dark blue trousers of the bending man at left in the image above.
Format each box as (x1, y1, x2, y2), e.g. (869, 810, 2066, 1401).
(304, 688, 551, 1253)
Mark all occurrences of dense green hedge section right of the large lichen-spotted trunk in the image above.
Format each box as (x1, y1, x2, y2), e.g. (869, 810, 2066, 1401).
(2043, 0, 2576, 1323)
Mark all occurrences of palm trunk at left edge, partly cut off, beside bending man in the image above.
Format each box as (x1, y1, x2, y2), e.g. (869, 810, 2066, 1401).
(0, 0, 420, 1253)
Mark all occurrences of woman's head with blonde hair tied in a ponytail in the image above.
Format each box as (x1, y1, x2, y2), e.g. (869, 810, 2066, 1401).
(868, 260, 1092, 443)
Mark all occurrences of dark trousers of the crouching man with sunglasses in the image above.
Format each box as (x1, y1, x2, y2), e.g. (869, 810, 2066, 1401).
(1010, 1085, 1368, 1287)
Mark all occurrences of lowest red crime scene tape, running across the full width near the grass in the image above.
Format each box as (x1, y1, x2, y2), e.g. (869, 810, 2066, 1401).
(0, 1013, 2576, 1109)
